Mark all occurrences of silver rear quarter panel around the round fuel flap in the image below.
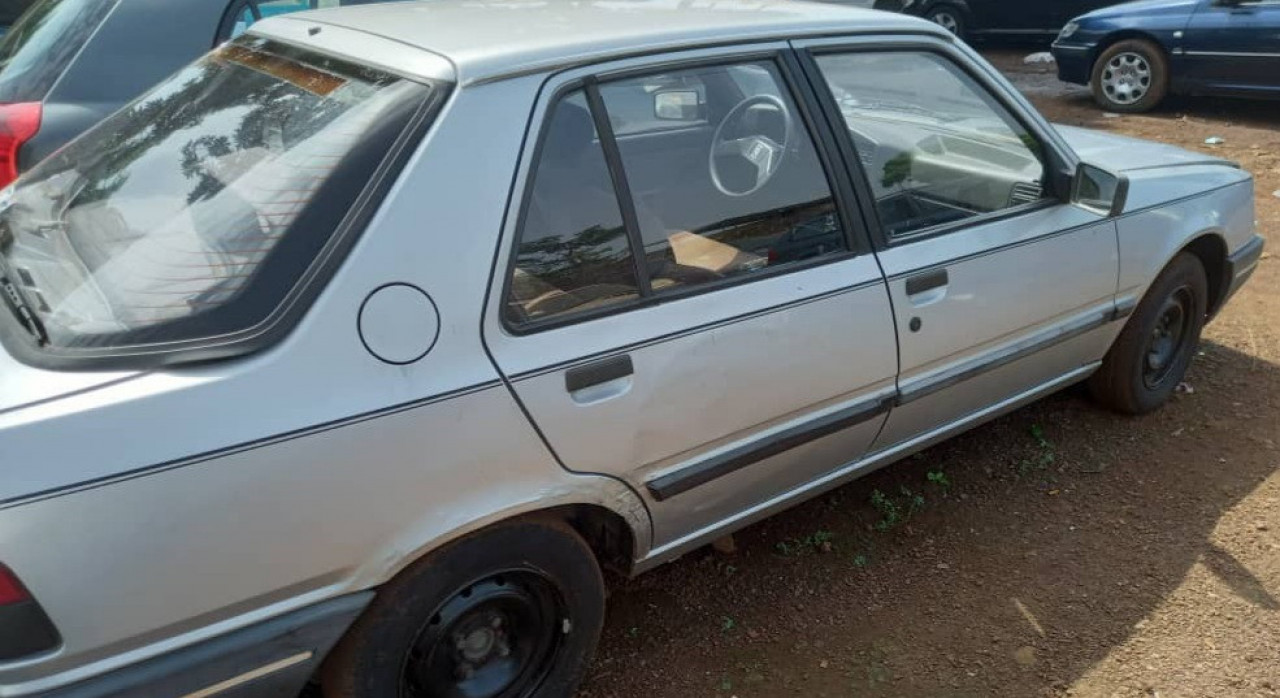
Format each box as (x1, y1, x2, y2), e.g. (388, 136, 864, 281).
(0, 76, 650, 695)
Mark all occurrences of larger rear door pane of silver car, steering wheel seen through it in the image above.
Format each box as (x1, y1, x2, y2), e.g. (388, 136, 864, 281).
(602, 61, 847, 292)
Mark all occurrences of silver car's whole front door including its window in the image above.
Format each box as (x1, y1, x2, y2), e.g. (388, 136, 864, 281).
(798, 41, 1119, 451)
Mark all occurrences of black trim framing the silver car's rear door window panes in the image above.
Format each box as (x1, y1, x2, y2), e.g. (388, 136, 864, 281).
(498, 49, 873, 337)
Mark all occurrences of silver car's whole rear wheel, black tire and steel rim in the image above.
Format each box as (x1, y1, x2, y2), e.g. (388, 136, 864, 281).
(321, 519, 604, 698)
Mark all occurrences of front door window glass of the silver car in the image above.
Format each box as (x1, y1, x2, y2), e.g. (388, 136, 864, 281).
(818, 53, 1046, 236)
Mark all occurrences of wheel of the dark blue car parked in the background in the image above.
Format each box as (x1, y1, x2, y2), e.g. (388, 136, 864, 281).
(1089, 38, 1169, 114)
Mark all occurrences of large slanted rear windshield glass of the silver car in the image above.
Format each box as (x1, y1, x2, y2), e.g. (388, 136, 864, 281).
(0, 37, 442, 356)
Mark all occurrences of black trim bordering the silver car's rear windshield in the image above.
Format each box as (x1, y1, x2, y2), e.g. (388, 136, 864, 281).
(0, 68, 456, 370)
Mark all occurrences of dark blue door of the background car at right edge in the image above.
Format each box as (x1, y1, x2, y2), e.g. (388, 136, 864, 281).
(1175, 0, 1280, 96)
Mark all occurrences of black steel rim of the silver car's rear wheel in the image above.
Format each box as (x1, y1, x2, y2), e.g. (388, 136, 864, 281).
(399, 570, 567, 698)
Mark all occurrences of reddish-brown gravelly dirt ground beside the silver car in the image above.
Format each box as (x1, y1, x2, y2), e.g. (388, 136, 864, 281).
(581, 50, 1280, 698)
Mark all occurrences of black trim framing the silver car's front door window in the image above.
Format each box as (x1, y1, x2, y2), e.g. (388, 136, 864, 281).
(797, 37, 1070, 251)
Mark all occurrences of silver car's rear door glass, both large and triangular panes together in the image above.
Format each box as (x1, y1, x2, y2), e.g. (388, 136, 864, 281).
(506, 61, 850, 324)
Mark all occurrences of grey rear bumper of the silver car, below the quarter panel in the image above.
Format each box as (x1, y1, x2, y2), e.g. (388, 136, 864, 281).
(42, 592, 374, 698)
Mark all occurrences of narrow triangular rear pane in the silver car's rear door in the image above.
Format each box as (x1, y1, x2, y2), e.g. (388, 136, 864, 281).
(507, 92, 639, 323)
